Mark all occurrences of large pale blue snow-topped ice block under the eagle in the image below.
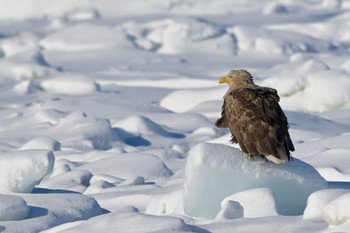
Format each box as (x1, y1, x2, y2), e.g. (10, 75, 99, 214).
(184, 143, 327, 218)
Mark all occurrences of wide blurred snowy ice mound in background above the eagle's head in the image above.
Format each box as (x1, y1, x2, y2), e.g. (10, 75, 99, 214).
(146, 19, 236, 55)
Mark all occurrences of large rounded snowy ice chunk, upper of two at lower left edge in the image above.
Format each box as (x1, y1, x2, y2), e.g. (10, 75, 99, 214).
(0, 150, 55, 193)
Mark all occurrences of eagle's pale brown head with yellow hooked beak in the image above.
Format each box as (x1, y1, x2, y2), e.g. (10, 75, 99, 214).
(219, 70, 254, 89)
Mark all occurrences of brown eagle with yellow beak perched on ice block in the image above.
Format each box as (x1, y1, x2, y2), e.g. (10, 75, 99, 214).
(215, 70, 294, 164)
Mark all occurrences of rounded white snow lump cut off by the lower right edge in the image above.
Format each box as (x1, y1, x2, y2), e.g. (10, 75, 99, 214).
(323, 193, 350, 225)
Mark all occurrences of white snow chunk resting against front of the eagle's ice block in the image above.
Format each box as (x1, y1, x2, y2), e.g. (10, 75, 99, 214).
(220, 188, 277, 218)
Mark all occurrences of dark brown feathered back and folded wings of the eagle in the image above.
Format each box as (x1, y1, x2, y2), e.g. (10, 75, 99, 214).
(225, 85, 294, 159)
